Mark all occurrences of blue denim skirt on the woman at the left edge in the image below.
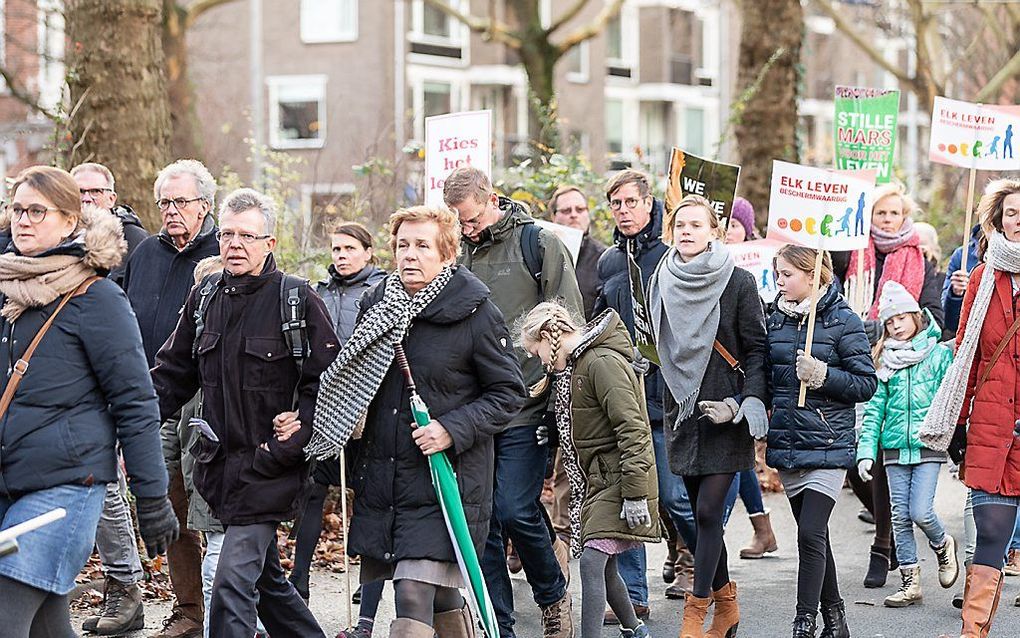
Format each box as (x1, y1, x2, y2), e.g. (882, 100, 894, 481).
(0, 483, 106, 592)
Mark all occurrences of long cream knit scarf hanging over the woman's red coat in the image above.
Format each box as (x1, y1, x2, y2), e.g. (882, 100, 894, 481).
(919, 232, 1020, 452)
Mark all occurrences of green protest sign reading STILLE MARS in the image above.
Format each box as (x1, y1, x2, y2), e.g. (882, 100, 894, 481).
(832, 87, 900, 184)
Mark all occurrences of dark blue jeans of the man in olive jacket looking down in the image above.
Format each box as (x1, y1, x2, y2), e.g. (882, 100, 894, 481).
(481, 425, 567, 638)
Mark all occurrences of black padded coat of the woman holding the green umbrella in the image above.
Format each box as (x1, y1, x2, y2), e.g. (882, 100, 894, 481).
(347, 266, 524, 562)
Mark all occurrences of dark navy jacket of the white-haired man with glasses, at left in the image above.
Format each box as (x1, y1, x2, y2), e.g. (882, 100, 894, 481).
(122, 215, 220, 365)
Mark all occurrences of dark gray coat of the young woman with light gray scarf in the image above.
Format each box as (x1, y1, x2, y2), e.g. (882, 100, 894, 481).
(663, 268, 768, 476)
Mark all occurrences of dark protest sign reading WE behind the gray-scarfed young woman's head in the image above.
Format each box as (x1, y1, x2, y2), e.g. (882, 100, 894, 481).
(666, 148, 741, 219)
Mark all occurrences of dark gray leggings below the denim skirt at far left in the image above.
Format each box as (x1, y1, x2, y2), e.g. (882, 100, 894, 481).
(0, 576, 78, 638)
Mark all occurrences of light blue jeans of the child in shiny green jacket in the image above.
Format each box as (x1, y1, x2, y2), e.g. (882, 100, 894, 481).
(885, 462, 946, 567)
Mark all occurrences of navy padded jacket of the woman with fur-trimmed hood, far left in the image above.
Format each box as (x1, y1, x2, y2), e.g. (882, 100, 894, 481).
(0, 244, 167, 498)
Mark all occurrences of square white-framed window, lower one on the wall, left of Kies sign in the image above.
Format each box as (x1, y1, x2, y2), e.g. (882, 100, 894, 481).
(267, 76, 325, 148)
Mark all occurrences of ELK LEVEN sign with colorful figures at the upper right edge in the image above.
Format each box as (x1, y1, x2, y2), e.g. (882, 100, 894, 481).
(928, 97, 1020, 170)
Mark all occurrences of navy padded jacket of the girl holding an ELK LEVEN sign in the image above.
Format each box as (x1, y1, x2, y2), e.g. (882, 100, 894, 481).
(766, 286, 878, 470)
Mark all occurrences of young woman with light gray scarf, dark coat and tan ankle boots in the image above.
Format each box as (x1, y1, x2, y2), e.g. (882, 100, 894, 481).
(649, 195, 768, 638)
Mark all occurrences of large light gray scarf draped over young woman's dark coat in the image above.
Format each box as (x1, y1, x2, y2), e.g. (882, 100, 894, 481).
(649, 242, 734, 428)
